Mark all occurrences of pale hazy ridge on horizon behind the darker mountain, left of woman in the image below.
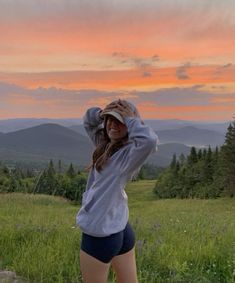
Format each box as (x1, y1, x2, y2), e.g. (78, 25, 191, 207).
(0, 118, 82, 133)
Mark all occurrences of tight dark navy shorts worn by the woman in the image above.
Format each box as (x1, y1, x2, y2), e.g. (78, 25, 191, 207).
(81, 223, 135, 263)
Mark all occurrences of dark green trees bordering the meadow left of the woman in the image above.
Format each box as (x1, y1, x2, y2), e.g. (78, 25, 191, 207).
(0, 160, 87, 202)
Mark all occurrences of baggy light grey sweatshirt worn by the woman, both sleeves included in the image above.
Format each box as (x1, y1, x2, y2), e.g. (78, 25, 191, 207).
(76, 107, 158, 237)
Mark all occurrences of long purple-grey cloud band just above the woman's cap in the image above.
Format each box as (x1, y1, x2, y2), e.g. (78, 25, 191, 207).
(0, 83, 229, 106)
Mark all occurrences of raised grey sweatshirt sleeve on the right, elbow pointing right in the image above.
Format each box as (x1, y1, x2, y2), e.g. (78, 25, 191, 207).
(121, 117, 159, 174)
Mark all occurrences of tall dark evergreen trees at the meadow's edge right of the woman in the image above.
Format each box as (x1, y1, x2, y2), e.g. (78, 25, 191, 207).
(154, 116, 235, 198)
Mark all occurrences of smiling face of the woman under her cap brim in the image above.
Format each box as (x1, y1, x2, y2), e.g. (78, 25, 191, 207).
(106, 115, 127, 142)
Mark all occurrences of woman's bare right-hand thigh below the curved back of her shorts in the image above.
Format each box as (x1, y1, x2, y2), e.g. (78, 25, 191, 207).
(111, 247, 138, 283)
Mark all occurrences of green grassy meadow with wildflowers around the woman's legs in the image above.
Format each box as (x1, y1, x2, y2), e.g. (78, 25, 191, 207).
(0, 181, 235, 283)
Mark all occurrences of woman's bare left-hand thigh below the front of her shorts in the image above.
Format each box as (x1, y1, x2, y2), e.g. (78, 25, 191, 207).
(80, 250, 110, 283)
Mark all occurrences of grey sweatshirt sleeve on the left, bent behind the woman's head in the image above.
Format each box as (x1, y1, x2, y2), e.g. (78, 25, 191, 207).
(83, 107, 103, 146)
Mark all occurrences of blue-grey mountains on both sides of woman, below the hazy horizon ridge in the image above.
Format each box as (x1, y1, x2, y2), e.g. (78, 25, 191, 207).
(0, 120, 228, 169)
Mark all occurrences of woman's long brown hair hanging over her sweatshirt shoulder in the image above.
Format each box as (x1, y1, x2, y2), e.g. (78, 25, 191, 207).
(87, 117, 128, 172)
